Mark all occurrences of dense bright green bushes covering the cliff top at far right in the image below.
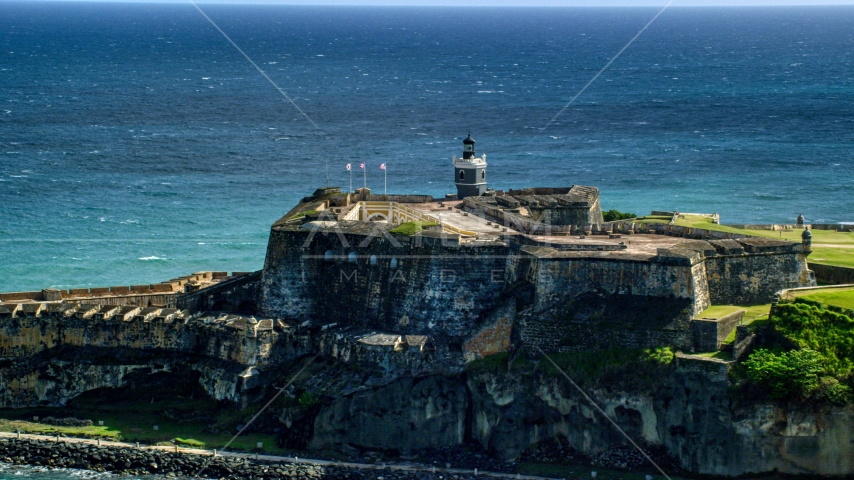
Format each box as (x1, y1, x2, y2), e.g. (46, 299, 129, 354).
(733, 299, 854, 404)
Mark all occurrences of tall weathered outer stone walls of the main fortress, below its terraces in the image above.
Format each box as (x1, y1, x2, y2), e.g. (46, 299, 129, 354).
(259, 204, 815, 358)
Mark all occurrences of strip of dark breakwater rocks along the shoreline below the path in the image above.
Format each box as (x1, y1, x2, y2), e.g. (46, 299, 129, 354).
(0, 439, 512, 480)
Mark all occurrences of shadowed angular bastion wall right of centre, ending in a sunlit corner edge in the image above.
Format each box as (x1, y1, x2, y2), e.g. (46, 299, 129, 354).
(516, 257, 709, 352)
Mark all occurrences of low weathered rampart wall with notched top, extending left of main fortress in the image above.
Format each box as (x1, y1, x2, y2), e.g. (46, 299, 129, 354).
(0, 302, 315, 406)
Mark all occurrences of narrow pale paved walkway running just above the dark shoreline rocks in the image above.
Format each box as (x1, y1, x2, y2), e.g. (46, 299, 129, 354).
(0, 432, 552, 480)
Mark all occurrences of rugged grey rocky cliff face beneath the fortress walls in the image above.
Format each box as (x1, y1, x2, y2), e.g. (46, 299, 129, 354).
(285, 359, 854, 476)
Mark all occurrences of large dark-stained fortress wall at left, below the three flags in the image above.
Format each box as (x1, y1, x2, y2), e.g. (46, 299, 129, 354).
(261, 227, 508, 338)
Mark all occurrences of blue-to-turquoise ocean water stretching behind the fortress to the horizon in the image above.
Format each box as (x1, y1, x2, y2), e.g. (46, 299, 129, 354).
(0, 1, 854, 291)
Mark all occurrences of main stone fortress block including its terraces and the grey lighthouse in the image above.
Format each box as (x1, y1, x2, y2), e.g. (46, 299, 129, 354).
(258, 136, 815, 359)
